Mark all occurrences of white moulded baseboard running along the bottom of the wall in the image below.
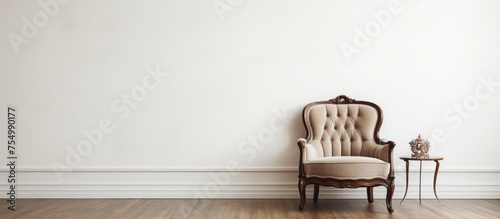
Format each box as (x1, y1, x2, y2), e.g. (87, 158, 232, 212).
(0, 167, 500, 199)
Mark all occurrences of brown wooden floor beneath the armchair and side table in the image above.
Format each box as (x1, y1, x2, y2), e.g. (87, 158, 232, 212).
(0, 199, 500, 219)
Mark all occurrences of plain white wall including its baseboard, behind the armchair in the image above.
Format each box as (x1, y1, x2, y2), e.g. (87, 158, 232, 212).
(0, 0, 500, 198)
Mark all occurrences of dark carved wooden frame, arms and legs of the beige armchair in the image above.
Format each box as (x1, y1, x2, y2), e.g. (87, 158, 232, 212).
(297, 95, 396, 213)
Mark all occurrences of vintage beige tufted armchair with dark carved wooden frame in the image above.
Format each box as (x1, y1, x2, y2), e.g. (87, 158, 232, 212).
(297, 95, 396, 213)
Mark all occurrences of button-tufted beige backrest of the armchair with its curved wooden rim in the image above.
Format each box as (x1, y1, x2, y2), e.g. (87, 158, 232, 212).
(303, 96, 382, 157)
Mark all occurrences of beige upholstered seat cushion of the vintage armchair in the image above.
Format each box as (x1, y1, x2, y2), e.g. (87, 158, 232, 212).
(304, 156, 390, 180)
